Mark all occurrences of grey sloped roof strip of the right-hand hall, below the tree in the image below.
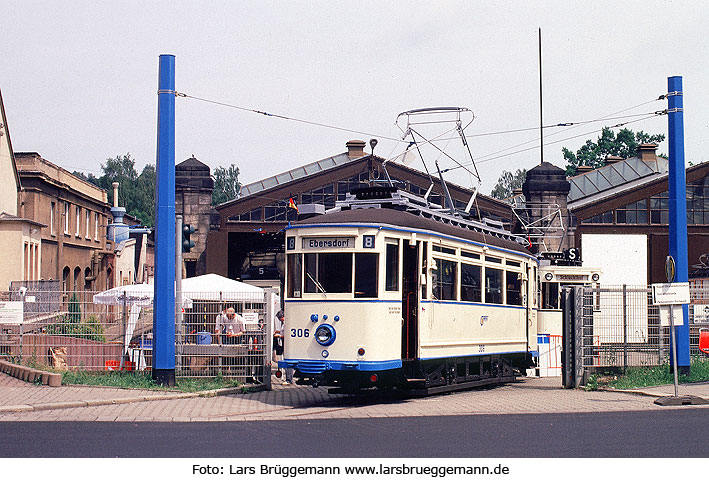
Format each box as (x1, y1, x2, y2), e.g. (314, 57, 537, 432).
(567, 156, 669, 206)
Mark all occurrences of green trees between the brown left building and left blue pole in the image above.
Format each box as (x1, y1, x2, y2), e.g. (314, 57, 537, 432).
(74, 154, 156, 227)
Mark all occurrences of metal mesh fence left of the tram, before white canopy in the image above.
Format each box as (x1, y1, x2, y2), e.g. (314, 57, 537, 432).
(0, 285, 278, 382)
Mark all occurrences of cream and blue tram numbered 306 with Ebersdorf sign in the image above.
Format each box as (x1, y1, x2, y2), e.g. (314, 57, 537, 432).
(279, 191, 537, 391)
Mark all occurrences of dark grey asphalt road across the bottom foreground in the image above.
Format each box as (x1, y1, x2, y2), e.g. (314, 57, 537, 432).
(0, 409, 709, 458)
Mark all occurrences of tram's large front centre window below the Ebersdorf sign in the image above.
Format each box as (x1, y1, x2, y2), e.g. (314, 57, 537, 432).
(305, 252, 352, 293)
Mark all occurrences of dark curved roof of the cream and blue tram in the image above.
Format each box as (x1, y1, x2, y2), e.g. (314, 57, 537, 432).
(292, 208, 534, 257)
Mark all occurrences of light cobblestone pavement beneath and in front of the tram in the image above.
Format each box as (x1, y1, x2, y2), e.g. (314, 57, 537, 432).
(0, 374, 709, 422)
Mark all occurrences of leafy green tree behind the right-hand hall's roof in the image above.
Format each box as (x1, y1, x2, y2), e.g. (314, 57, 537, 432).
(561, 127, 665, 176)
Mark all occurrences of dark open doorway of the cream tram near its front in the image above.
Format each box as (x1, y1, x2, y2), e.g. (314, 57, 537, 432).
(401, 240, 421, 360)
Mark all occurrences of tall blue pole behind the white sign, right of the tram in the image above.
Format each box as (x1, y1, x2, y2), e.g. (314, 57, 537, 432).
(667, 76, 690, 375)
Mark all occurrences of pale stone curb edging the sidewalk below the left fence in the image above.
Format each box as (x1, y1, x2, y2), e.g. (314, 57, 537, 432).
(0, 384, 266, 414)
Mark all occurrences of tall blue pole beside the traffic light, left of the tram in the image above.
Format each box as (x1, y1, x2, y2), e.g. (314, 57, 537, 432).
(153, 54, 175, 385)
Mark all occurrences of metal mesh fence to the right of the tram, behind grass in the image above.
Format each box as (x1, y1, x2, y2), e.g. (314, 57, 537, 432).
(562, 280, 709, 386)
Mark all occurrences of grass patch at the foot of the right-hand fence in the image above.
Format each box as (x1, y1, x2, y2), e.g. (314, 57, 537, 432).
(586, 358, 709, 390)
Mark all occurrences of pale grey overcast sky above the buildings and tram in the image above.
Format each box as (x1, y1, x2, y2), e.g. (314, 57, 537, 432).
(0, 0, 709, 193)
